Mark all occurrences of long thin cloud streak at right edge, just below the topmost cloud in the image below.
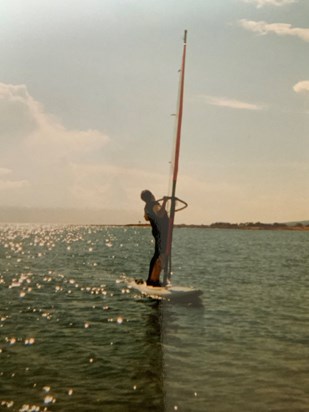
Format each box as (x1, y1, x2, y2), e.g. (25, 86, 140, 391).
(239, 19, 309, 42)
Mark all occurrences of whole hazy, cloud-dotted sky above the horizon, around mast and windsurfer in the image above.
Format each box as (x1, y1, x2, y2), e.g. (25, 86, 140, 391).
(0, 0, 309, 224)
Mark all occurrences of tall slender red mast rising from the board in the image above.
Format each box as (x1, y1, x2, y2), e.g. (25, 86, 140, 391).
(163, 30, 187, 284)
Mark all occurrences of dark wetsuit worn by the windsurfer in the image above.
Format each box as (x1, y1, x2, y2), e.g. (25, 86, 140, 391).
(145, 201, 169, 281)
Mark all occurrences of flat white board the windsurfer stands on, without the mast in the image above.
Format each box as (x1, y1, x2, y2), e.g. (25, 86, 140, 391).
(127, 279, 203, 300)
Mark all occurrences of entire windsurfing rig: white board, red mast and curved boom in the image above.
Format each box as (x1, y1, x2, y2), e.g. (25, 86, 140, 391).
(127, 30, 203, 299)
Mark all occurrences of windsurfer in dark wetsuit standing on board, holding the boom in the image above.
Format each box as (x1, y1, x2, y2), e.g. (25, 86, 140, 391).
(141, 190, 169, 286)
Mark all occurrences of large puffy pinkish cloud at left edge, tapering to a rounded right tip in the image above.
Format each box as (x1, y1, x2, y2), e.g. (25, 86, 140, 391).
(0, 83, 110, 155)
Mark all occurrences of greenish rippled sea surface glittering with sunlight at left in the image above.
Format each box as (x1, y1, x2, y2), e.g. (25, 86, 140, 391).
(0, 225, 309, 412)
